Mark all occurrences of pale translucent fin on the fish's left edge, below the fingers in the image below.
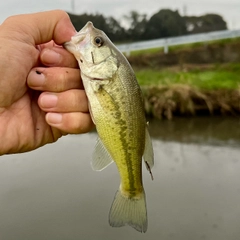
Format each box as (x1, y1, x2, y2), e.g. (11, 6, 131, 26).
(92, 138, 113, 171)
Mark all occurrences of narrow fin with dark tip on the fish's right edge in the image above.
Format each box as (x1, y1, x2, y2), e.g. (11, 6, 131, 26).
(143, 127, 154, 180)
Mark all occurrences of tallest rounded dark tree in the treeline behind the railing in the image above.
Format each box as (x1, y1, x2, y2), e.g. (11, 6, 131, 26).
(144, 9, 187, 39)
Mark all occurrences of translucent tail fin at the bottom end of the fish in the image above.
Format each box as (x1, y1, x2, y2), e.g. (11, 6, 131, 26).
(109, 190, 148, 232)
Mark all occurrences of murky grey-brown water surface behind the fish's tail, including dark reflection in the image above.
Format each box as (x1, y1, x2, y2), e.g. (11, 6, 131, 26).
(0, 118, 240, 240)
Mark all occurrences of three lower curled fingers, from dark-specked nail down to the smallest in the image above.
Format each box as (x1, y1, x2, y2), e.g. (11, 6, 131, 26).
(27, 67, 94, 134)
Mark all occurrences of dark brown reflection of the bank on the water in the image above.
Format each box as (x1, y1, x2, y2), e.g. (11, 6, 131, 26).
(150, 117, 240, 146)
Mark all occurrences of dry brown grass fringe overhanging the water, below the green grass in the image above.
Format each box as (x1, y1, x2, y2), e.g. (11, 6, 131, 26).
(142, 84, 240, 120)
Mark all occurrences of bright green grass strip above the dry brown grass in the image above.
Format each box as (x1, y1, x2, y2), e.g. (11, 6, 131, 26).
(135, 63, 240, 90)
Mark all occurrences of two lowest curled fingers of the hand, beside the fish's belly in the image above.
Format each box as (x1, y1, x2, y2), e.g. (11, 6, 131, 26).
(38, 89, 93, 134)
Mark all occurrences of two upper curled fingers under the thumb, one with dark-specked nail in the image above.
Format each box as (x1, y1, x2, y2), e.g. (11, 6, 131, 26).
(27, 41, 83, 92)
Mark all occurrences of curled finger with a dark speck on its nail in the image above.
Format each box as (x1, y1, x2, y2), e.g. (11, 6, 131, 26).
(27, 67, 83, 92)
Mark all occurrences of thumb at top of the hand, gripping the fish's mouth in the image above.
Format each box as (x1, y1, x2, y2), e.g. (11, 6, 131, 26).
(1, 10, 76, 45)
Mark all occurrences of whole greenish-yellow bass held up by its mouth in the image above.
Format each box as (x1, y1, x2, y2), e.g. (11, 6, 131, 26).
(64, 22, 154, 232)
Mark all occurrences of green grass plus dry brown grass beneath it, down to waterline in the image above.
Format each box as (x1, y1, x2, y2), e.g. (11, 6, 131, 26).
(135, 63, 240, 119)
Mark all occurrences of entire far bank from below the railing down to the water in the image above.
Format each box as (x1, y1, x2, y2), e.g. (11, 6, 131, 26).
(128, 39, 240, 119)
